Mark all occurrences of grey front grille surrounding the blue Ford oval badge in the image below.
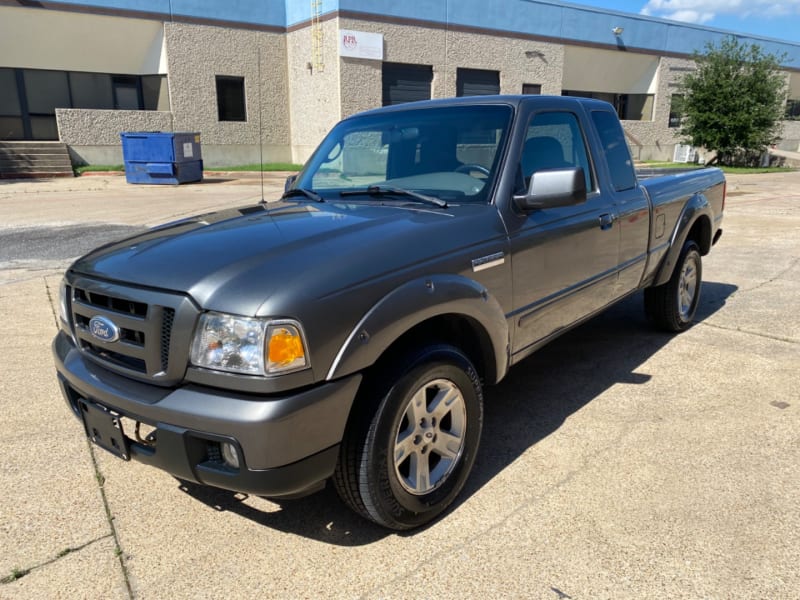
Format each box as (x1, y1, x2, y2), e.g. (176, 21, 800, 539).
(70, 278, 197, 385)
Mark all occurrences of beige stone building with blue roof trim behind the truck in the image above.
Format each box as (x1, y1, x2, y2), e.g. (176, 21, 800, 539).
(0, 0, 800, 166)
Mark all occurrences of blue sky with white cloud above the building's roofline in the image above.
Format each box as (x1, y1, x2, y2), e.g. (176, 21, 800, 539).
(567, 0, 800, 42)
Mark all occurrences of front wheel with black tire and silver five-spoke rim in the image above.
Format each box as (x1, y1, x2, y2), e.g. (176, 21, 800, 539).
(334, 345, 483, 530)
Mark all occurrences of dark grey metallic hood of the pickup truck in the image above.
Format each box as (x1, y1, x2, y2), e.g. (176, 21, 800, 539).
(72, 201, 500, 315)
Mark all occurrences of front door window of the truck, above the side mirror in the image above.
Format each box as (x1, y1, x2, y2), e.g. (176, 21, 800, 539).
(520, 112, 594, 191)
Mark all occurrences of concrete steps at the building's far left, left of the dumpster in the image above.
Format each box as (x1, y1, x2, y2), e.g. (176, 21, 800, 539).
(0, 141, 74, 179)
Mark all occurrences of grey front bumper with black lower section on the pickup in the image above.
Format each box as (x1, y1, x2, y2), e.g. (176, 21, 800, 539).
(53, 332, 361, 497)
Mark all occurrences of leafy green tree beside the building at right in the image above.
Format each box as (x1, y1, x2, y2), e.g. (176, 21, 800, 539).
(681, 36, 786, 165)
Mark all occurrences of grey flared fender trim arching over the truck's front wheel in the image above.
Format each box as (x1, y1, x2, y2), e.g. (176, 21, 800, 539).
(326, 275, 509, 380)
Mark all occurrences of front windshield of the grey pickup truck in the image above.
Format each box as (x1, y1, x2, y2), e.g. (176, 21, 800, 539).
(293, 105, 512, 203)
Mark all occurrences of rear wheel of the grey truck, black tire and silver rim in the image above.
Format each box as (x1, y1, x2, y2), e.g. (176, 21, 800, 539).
(644, 240, 703, 333)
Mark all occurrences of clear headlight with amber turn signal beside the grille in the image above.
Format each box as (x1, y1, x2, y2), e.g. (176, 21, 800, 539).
(191, 312, 308, 375)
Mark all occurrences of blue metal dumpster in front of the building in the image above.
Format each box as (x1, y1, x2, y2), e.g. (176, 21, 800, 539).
(119, 131, 203, 185)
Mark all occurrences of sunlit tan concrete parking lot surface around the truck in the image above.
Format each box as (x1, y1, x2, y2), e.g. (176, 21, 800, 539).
(0, 173, 800, 600)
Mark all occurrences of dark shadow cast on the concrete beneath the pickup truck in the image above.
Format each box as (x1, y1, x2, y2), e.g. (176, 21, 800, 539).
(175, 282, 738, 546)
